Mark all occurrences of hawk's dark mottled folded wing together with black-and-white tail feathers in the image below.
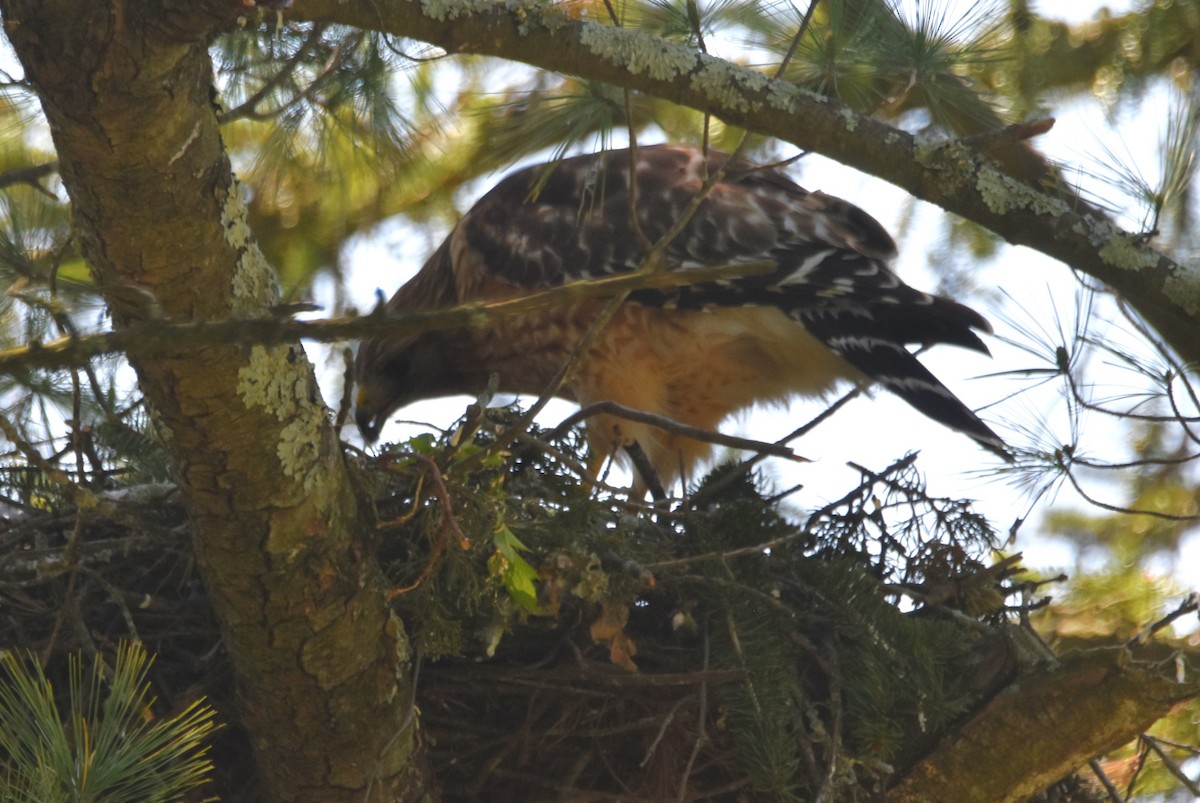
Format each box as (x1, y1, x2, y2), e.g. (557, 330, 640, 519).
(444, 145, 1004, 454)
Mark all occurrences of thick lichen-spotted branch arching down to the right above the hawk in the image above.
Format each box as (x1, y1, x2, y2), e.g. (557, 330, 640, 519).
(290, 0, 1200, 361)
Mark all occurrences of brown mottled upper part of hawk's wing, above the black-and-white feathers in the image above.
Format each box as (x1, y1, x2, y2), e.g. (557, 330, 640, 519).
(456, 145, 895, 292)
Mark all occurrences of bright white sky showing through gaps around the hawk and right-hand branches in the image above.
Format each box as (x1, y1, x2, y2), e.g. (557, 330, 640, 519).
(328, 0, 1200, 578)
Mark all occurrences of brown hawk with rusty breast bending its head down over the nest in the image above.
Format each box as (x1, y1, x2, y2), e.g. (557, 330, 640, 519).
(355, 145, 1004, 487)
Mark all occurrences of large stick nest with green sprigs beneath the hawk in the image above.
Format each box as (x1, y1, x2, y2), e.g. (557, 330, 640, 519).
(0, 412, 1082, 801)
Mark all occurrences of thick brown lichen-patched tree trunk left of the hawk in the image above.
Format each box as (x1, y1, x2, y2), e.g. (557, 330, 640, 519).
(0, 0, 424, 801)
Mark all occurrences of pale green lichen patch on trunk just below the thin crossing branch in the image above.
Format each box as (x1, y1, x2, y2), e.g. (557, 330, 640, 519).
(238, 346, 328, 492)
